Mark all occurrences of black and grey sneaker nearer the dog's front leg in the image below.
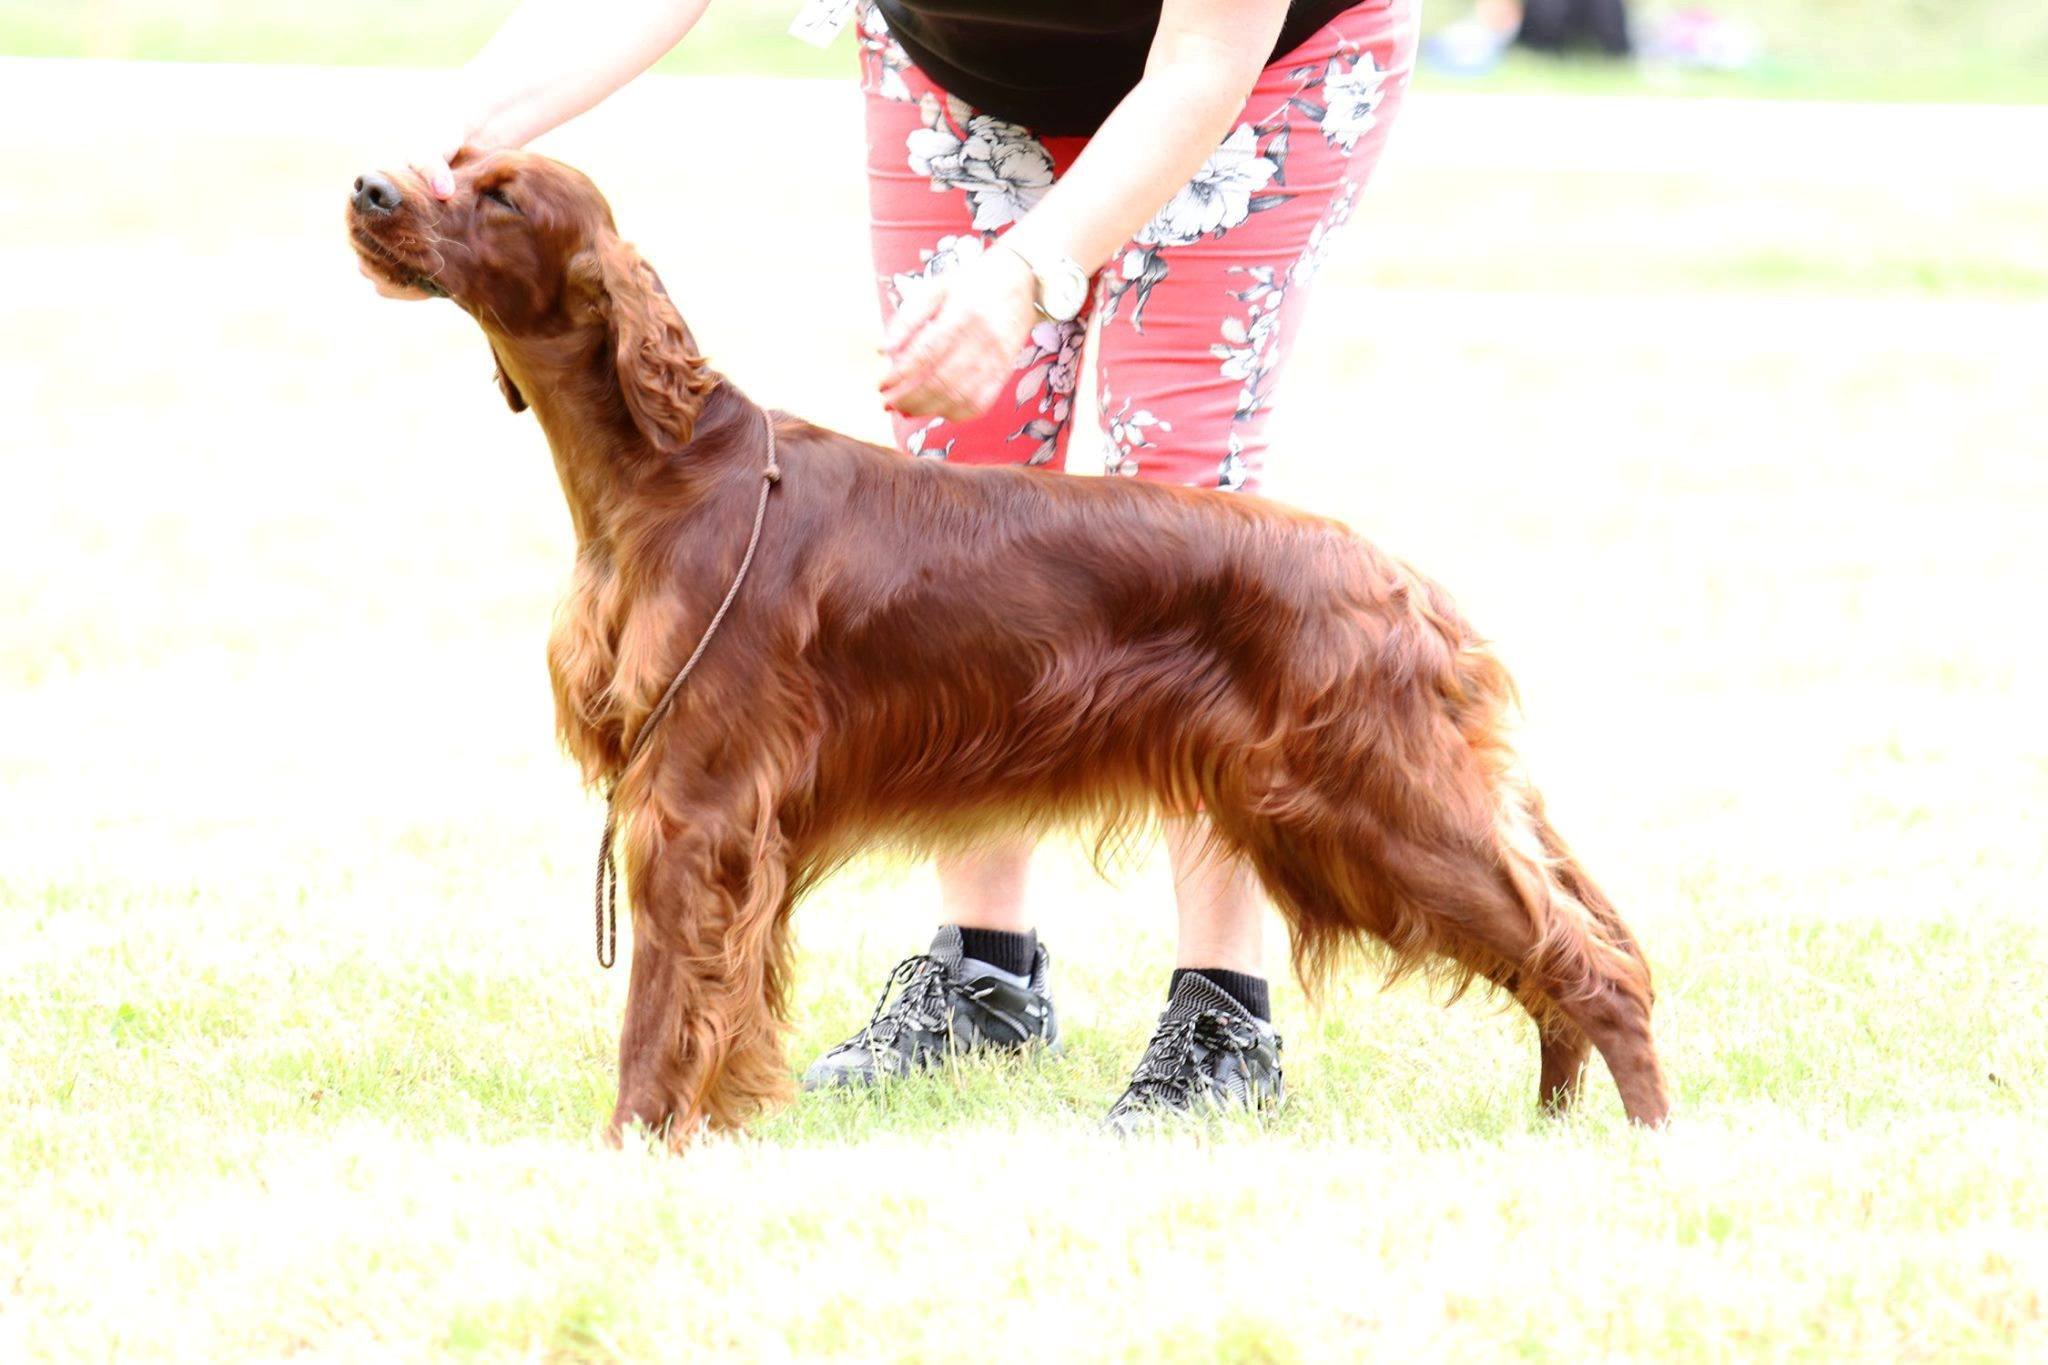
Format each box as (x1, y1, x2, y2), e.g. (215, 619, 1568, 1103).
(803, 925, 1059, 1091)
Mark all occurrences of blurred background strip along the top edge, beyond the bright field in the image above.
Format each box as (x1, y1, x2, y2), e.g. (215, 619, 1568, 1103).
(12, 0, 2048, 102)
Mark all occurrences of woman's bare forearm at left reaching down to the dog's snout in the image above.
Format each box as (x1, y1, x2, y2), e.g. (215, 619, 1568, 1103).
(410, 0, 711, 199)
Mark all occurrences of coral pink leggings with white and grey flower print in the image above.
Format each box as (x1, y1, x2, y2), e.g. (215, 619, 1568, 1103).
(860, 0, 1415, 489)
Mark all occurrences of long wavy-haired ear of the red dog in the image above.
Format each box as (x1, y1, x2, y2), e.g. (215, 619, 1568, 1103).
(578, 235, 719, 450)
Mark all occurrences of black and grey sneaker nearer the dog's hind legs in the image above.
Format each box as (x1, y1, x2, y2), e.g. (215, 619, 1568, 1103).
(1104, 972, 1284, 1134)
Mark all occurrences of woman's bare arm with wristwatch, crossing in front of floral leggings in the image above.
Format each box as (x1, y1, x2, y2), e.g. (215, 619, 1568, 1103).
(881, 0, 1288, 420)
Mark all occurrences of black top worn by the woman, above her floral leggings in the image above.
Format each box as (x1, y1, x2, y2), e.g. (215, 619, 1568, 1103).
(874, 0, 1358, 137)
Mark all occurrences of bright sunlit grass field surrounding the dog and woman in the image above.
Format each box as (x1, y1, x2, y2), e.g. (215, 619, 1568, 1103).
(0, 63, 2048, 1361)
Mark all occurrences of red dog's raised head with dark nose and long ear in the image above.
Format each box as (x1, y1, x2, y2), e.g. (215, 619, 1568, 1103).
(348, 151, 717, 450)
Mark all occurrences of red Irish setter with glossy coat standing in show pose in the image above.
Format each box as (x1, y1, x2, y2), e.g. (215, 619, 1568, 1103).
(348, 153, 1665, 1142)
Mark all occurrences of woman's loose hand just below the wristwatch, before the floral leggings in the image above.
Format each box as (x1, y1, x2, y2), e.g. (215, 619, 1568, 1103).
(881, 248, 1038, 422)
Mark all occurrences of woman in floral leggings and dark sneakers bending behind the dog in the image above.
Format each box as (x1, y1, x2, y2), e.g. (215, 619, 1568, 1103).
(379, 0, 1415, 1126)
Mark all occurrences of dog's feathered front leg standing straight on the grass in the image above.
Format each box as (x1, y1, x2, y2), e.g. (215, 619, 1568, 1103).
(612, 784, 791, 1148)
